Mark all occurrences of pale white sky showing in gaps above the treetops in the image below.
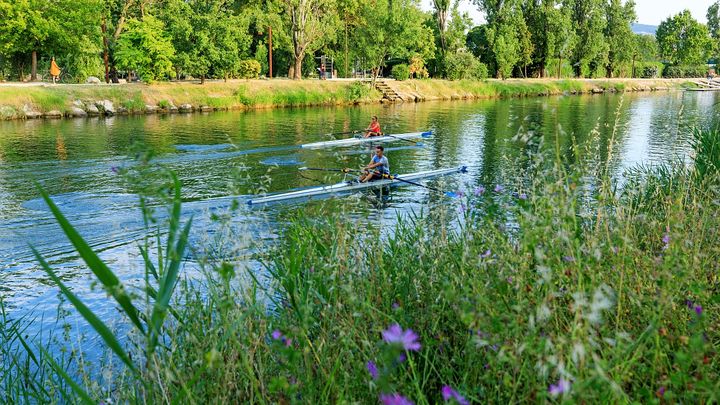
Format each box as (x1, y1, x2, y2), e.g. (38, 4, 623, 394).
(421, 0, 714, 25)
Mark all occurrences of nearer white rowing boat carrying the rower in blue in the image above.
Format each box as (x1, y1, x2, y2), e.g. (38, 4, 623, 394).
(247, 166, 467, 205)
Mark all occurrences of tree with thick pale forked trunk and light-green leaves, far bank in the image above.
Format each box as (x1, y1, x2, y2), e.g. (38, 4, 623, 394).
(285, 0, 339, 80)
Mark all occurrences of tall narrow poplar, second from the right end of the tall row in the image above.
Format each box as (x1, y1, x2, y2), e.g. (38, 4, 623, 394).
(567, 0, 608, 77)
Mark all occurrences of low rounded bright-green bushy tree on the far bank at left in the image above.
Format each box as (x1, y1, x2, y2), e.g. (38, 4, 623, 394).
(115, 15, 175, 81)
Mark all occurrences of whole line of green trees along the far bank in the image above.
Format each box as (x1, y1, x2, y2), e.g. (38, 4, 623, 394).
(0, 0, 720, 82)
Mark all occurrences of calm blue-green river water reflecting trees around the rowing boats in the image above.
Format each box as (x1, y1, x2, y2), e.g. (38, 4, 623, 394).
(0, 92, 720, 327)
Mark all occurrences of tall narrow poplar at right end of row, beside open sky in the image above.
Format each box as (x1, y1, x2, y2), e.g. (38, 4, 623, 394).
(605, 0, 636, 77)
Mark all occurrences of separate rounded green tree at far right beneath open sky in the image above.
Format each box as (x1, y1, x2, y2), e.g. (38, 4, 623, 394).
(655, 10, 712, 65)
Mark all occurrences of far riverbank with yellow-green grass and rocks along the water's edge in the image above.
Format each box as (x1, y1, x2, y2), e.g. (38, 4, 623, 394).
(0, 79, 686, 120)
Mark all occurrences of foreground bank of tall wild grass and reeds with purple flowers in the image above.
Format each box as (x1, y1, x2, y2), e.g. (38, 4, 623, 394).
(0, 119, 720, 404)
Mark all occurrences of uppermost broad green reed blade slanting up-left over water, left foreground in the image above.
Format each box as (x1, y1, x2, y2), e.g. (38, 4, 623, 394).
(36, 185, 145, 334)
